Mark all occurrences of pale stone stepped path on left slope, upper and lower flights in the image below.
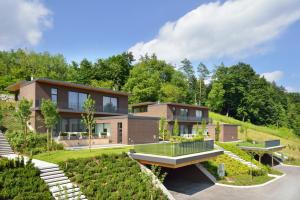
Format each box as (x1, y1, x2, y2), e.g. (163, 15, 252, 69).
(0, 132, 87, 200)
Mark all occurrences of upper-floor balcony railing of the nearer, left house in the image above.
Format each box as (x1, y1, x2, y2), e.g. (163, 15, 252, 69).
(35, 100, 128, 114)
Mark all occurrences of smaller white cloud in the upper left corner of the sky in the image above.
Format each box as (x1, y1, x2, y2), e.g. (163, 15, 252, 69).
(0, 0, 52, 50)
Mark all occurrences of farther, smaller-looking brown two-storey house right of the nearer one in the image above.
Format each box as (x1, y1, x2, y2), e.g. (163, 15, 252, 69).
(131, 102, 209, 135)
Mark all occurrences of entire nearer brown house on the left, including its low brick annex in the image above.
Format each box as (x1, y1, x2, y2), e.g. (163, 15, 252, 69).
(6, 78, 159, 146)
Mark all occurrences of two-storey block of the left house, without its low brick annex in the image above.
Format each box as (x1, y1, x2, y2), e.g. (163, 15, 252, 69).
(7, 78, 128, 136)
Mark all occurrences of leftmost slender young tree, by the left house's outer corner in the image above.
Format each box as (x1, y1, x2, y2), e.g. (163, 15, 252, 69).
(16, 98, 32, 147)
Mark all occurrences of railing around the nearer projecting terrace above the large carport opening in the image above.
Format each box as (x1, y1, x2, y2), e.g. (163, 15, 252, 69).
(134, 140, 214, 157)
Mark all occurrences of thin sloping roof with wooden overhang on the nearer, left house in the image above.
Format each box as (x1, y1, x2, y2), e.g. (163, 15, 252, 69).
(5, 78, 129, 96)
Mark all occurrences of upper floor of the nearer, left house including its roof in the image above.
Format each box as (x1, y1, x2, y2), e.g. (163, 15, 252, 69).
(7, 78, 128, 114)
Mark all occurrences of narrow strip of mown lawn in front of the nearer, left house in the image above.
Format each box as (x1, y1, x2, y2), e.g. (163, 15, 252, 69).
(33, 146, 132, 163)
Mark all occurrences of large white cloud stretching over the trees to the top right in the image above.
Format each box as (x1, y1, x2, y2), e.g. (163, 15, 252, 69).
(129, 0, 300, 63)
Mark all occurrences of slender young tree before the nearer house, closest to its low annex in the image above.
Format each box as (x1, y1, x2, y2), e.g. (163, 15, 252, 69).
(81, 95, 96, 151)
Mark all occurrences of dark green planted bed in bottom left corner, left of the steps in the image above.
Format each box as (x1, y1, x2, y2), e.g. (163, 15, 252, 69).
(0, 158, 52, 200)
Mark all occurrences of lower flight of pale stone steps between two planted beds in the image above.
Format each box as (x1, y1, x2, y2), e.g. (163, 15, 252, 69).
(39, 165, 87, 200)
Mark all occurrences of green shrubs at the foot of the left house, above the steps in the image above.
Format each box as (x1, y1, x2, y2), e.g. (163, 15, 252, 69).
(5, 131, 64, 155)
